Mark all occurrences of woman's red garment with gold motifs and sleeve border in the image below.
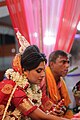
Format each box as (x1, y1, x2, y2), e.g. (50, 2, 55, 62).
(0, 80, 37, 120)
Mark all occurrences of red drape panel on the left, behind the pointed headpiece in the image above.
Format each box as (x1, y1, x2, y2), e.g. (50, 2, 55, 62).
(6, 0, 30, 42)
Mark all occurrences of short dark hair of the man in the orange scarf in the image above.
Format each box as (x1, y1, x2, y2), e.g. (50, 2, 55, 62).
(49, 50, 71, 64)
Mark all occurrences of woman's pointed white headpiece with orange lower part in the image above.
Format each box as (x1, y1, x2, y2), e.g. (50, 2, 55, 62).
(12, 29, 30, 73)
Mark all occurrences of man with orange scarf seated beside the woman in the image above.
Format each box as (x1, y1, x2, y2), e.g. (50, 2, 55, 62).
(46, 50, 73, 118)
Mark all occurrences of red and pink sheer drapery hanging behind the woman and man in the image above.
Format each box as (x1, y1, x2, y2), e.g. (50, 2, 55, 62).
(6, 0, 80, 57)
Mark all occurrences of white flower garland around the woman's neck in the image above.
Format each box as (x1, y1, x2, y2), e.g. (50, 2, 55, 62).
(5, 69, 42, 119)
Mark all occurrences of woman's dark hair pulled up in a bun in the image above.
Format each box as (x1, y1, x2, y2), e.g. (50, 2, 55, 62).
(21, 45, 47, 70)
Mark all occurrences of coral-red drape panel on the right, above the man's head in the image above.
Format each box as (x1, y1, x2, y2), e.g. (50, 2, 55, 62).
(55, 0, 80, 52)
